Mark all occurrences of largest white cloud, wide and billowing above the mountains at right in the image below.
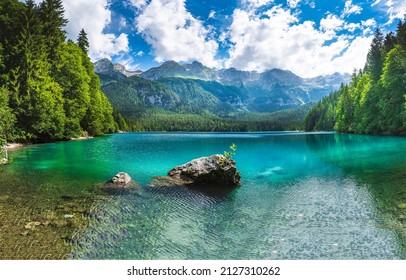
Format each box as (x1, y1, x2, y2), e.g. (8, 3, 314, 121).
(225, 6, 371, 77)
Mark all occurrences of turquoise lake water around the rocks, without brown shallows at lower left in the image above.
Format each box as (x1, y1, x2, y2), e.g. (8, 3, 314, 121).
(6, 133, 406, 259)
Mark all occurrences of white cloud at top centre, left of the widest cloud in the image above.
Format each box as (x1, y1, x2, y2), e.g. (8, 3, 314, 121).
(136, 0, 218, 67)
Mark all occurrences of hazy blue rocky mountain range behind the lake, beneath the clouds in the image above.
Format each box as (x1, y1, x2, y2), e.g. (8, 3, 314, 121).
(94, 59, 350, 117)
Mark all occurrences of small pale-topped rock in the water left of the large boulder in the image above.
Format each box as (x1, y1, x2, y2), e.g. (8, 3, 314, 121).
(96, 172, 140, 194)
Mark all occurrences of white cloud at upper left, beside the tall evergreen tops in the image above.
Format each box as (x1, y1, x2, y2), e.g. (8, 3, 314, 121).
(63, 0, 129, 60)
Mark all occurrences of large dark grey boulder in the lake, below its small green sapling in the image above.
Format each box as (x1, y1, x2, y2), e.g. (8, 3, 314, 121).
(150, 155, 240, 187)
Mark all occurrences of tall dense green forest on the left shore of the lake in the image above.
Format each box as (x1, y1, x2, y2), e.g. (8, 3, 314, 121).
(0, 0, 122, 158)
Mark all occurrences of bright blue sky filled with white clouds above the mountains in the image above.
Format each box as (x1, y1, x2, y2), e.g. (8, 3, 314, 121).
(31, 0, 406, 77)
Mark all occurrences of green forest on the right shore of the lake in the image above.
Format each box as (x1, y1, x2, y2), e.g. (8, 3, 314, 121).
(304, 19, 406, 135)
